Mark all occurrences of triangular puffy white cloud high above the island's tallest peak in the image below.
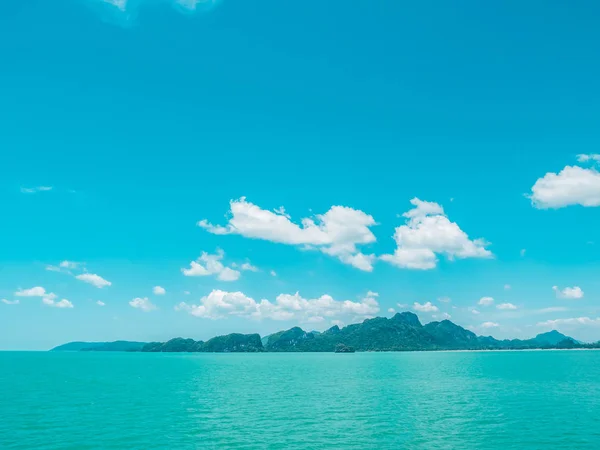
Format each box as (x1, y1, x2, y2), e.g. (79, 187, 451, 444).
(381, 198, 492, 270)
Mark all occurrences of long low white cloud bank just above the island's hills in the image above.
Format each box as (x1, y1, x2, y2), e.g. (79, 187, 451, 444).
(175, 290, 379, 323)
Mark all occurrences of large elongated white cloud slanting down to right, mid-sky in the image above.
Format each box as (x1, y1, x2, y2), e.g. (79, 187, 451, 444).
(198, 197, 376, 272)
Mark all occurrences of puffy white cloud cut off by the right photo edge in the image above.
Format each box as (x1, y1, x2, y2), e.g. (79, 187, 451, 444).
(529, 166, 600, 209)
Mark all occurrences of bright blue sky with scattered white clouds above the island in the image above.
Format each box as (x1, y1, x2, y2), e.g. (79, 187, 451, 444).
(0, 0, 600, 350)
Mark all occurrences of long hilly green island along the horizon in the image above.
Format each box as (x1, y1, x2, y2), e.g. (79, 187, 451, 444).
(51, 312, 600, 353)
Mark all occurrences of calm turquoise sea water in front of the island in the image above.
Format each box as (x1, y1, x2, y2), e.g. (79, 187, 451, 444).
(0, 351, 600, 449)
